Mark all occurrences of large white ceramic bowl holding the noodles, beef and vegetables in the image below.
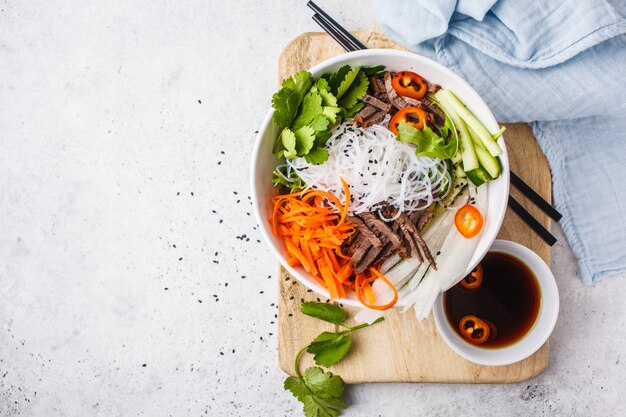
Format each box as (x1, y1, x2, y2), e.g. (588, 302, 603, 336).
(250, 49, 509, 307)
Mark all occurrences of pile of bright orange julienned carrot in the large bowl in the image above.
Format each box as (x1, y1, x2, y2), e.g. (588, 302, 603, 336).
(271, 179, 397, 310)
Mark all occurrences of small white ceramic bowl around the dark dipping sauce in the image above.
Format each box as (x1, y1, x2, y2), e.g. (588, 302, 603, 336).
(433, 240, 559, 366)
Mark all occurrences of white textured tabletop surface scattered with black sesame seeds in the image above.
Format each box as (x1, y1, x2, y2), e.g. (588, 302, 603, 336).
(0, 0, 626, 417)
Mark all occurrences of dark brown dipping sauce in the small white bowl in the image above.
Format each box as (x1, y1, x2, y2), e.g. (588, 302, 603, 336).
(443, 252, 541, 348)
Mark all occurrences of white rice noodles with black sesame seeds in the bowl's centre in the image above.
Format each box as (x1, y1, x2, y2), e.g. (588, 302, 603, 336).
(287, 122, 451, 216)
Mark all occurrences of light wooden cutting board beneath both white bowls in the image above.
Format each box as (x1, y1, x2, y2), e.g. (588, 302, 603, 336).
(278, 31, 552, 383)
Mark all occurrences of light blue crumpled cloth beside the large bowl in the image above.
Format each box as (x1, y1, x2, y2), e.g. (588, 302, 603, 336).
(372, 0, 626, 284)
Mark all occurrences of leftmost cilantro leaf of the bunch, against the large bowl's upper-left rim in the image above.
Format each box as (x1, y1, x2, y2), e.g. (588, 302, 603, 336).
(272, 71, 313, 128)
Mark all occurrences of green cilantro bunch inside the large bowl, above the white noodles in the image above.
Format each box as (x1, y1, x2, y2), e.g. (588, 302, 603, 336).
(272, 65, 372, 164)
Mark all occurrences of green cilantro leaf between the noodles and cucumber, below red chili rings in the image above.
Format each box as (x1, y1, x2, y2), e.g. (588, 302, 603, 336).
(397, 122, 458, 159)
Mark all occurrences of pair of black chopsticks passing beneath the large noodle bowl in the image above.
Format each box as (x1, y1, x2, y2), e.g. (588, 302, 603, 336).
(307, 1, 563, 246)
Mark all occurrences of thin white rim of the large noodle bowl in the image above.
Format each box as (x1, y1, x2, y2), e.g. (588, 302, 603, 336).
(250, 48, 510, 308)
